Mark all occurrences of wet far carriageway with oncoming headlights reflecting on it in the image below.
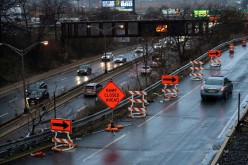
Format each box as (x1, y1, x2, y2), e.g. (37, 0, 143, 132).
(0, 46, 149, 124)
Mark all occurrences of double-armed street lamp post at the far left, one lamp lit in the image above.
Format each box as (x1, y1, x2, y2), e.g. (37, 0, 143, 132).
(0, 41, 48, 113)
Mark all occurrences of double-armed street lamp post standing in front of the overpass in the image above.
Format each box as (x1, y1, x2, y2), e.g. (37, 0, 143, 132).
(87, 25, 124, 74)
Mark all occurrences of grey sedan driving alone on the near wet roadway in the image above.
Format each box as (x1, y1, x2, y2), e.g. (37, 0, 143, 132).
(201, 76, 233, 100)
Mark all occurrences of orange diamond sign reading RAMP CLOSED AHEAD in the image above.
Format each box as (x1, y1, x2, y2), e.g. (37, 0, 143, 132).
(98, 81, 125, 109)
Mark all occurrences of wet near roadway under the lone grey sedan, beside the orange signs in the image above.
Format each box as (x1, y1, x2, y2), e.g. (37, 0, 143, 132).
(7, 43, 248, 165)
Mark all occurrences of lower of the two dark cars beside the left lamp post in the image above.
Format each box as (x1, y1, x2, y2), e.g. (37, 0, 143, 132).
(27, 89, 49, 105)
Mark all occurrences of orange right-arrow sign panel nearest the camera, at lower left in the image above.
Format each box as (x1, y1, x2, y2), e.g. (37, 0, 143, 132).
(50, 118, 72, 133)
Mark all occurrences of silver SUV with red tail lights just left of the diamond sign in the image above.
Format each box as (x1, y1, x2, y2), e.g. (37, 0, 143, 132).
(83, 83, 102, 97)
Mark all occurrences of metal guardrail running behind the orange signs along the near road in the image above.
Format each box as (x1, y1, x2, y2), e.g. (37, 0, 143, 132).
(0, 37, 248, 160)
